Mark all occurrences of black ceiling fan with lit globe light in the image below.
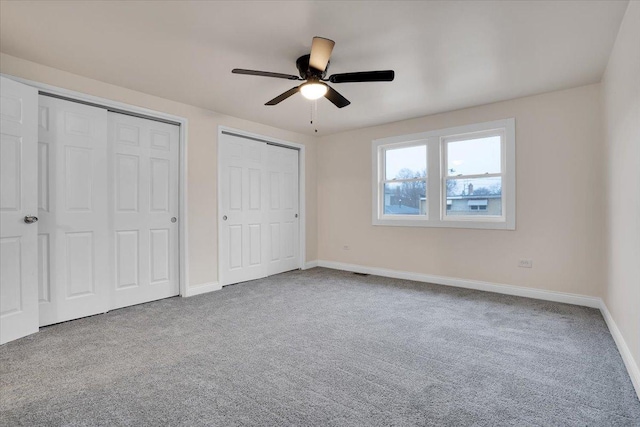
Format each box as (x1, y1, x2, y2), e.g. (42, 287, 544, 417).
(231, 37, 395, 108)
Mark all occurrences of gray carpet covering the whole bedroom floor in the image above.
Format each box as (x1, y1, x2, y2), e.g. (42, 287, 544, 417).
(0, 268, 640, 426)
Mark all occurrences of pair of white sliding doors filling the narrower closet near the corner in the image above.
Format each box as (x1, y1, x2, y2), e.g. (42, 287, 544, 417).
(218, 134, 300, 285)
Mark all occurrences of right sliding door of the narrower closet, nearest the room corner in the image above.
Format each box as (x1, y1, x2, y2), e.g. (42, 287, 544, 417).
(267, 145, 300, 275)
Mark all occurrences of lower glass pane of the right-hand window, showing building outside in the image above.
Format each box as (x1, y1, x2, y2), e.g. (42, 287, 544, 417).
(446, 177, 502, 216)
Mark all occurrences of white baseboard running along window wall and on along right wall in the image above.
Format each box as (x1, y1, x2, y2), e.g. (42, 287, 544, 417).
(306, 260, 640, 398)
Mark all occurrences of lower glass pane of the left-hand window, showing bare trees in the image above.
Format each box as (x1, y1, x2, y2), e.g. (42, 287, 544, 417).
(383, 181, 427, 215)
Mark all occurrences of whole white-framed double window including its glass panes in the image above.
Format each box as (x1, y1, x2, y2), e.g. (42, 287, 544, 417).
(372, 119, 515, 230)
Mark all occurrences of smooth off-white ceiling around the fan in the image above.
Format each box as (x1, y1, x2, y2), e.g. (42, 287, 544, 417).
(0, 0, 627, 135)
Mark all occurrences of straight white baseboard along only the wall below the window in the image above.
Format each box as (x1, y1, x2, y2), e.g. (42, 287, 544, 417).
(317, 260, 601, 308)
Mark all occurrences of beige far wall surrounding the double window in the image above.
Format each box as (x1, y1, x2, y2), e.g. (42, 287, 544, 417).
(318, 85, 604, 296)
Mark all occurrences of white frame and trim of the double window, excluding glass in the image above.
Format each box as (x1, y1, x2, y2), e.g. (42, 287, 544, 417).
(371, 118, 516, 230)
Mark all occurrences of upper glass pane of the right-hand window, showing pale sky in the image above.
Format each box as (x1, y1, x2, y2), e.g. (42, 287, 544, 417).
(446, 136, 501, 176)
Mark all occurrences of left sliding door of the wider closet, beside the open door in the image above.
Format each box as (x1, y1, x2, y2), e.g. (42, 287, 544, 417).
(38, 96, 111, 326)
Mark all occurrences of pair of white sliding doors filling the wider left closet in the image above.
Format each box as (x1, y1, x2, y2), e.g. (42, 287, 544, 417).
(38, 101, 179, 326)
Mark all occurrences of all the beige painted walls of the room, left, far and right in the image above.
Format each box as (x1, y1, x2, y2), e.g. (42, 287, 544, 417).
(0, 12, 640, 384)
